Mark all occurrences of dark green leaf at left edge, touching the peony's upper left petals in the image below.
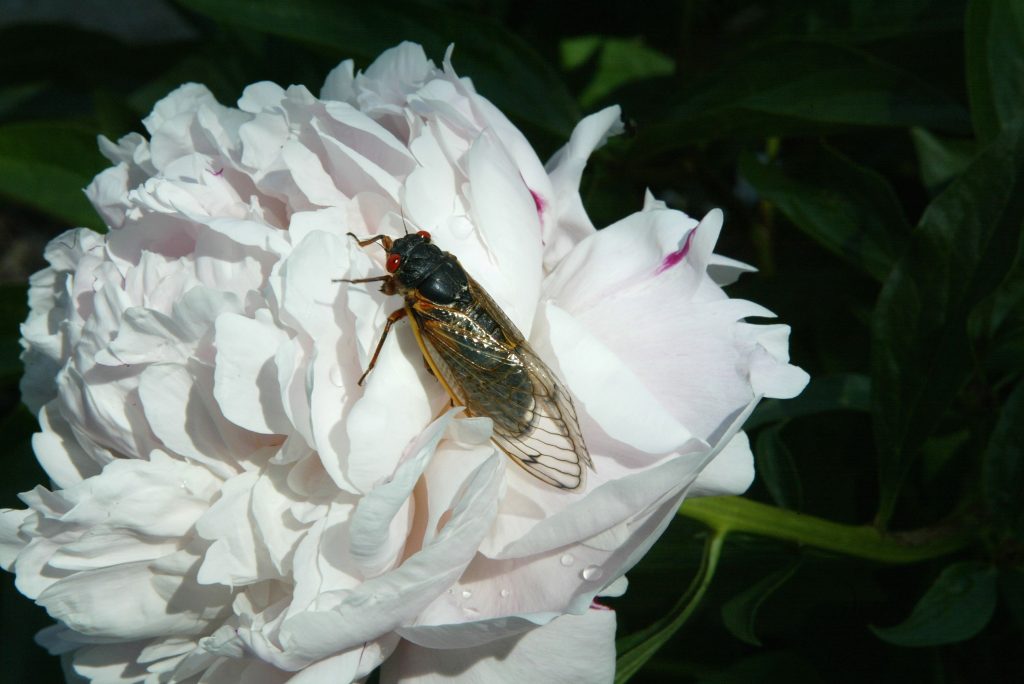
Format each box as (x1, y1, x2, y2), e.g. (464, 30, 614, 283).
(0, 123, 105, 227)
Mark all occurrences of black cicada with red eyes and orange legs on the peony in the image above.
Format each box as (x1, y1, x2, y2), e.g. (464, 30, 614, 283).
(344, 230, 594, 489)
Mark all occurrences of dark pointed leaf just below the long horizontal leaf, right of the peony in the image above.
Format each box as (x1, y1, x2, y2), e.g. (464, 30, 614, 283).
(739, 145, 910, 281)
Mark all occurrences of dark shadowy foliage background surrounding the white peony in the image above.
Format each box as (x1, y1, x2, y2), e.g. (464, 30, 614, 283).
(0, 0, 1024, 684)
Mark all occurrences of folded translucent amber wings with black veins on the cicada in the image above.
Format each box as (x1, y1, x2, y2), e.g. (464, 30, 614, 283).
(412, 279, 593, 489)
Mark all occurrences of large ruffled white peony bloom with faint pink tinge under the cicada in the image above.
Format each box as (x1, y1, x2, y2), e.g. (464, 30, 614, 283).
(0, 44, 807, 684)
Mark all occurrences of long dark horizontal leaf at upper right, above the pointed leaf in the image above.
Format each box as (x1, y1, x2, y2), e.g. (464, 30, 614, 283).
(634, 41, 970, 158)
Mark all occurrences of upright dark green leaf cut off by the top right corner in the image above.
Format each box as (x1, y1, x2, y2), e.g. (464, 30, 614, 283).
(965, 0, 1024, 142)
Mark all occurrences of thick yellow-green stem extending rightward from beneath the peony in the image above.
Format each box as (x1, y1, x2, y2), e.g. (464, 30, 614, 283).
(679, 497, 973, 563)
